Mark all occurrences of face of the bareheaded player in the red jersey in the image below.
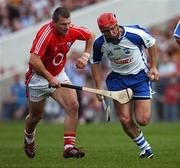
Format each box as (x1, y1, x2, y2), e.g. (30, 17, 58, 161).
(54, 16, 71, 35)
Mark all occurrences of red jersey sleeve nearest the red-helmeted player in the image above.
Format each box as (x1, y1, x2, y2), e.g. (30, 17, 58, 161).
(71, 25, 92, 41)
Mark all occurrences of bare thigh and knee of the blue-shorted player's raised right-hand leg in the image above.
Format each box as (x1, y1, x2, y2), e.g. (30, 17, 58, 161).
(134, 99, 151, 122)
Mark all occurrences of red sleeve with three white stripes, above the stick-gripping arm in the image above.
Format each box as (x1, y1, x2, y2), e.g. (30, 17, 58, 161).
(30, 26, 51, 57)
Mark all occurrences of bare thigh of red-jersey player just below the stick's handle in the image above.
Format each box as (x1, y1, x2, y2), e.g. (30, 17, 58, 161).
(51, 88, 79, 111)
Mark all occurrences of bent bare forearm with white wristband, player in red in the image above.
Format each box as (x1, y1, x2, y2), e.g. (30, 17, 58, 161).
(76, 34, 95, 69)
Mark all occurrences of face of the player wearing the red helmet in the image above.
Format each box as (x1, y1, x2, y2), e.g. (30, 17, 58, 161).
(101, 24, 119, 39)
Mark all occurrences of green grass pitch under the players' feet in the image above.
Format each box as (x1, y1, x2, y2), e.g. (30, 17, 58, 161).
(0, 122, 180, 168)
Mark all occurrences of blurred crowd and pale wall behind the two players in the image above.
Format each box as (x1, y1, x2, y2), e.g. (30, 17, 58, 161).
(0, 0, 180, 124)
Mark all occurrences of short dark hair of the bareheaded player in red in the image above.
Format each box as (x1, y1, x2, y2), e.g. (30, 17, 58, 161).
(52, 6, 70, 23)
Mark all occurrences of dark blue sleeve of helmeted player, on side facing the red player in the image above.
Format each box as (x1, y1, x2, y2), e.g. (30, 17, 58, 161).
(93, 36, 104, 63)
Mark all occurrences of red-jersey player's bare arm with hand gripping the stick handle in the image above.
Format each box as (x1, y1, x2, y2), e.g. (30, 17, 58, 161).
(30, 53, 60, 88)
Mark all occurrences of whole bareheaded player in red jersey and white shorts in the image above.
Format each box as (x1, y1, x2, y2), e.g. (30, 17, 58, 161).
(24, 7, 95, 158)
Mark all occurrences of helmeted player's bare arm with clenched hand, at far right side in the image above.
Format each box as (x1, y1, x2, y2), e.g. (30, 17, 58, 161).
(148, 44, 159, 80)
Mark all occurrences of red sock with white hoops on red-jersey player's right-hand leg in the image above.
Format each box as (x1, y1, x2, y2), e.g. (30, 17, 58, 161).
(64, 133, 76, 150)
